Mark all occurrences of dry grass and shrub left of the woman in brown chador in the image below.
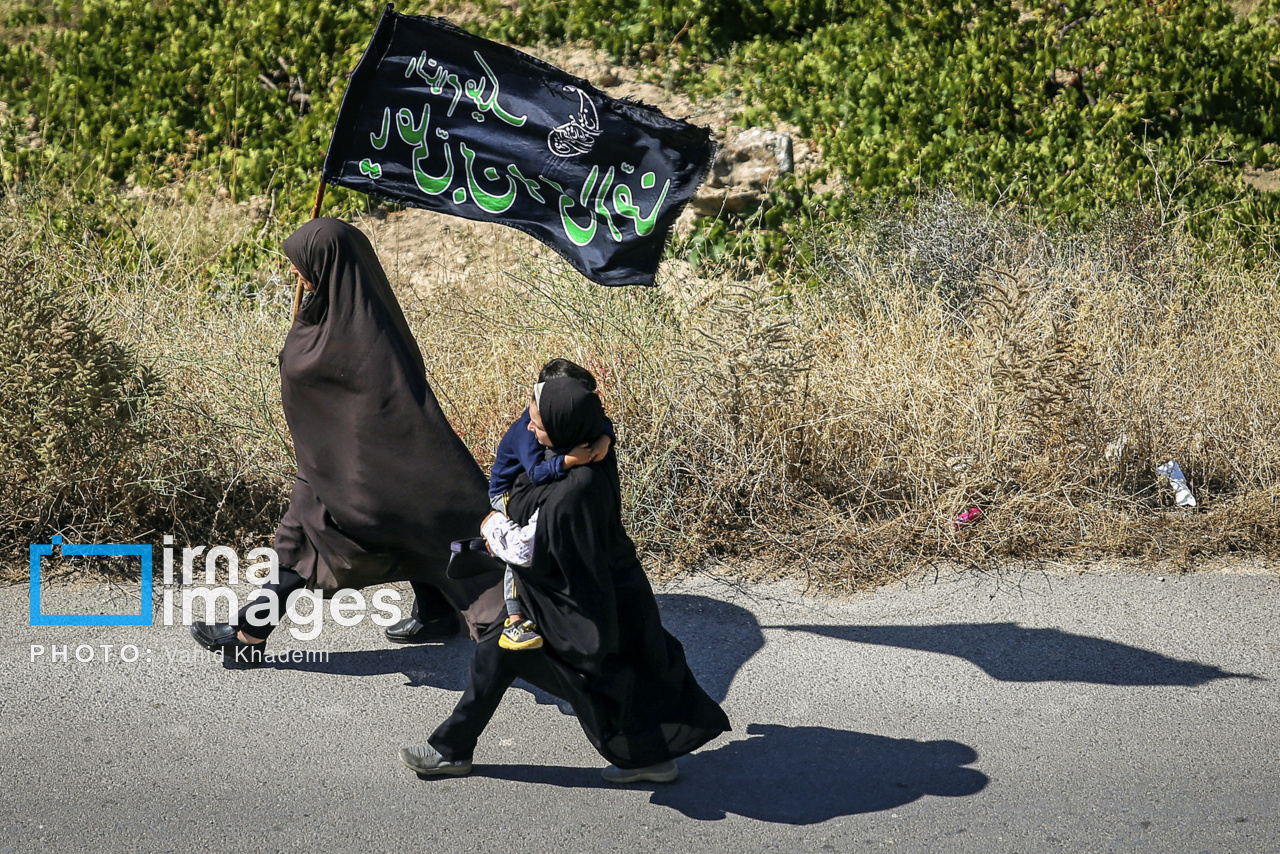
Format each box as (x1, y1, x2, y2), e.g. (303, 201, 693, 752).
(0, 185, 292, 573)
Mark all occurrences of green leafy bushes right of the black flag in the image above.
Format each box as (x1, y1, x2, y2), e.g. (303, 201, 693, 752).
(476, 0, 1280, 250)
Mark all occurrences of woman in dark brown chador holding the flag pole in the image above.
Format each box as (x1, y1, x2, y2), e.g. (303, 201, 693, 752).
(191, 219, 502, 666)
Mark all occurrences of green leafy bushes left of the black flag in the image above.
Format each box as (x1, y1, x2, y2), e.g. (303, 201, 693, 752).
(0, 0, 389, 207)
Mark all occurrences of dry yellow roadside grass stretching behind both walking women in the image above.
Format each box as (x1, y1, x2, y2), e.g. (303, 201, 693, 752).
(2, 185, 1280, 589)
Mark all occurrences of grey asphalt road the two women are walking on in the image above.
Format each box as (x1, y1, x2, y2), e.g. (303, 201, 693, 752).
(0, 574, 1280, 854)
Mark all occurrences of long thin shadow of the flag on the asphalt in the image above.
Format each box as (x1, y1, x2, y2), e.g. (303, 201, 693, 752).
(765, 622, 1260, 688)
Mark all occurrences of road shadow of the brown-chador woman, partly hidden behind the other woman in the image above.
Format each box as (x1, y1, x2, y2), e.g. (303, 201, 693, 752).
(274, 593, 764, 714)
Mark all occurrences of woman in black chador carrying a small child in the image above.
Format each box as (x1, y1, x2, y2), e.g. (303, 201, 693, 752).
(401, 378, 730, 782)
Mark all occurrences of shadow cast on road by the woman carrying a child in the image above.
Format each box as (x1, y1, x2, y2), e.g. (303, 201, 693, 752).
(475, 723, 988, 825)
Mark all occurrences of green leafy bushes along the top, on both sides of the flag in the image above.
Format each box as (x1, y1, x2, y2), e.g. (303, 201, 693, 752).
(0, 0, 1280, 268)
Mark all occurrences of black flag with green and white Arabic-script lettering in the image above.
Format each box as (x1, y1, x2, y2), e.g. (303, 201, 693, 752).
(324, 5, 714, 284)
